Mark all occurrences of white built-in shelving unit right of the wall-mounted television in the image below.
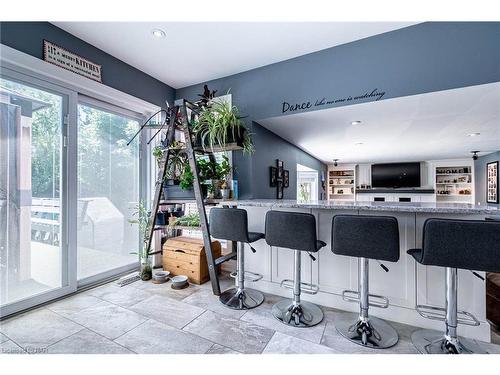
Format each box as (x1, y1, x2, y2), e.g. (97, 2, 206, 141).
(435, 165, 474, 203)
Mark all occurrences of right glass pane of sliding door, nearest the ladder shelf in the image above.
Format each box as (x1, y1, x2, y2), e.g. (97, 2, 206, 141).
(77, 103, 139, 280)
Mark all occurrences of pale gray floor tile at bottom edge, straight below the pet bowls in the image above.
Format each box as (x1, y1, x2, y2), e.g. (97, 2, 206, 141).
(115, 320, 212, 354)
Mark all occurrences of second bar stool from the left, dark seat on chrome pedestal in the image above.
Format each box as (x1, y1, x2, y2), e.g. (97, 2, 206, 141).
(266, 211, 326, 327)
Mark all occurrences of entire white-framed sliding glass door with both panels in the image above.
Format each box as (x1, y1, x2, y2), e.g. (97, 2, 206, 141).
(0, 66, 146, 316)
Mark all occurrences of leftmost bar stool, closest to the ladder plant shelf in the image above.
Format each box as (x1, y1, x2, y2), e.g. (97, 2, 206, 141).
(209, 208, 265, 310)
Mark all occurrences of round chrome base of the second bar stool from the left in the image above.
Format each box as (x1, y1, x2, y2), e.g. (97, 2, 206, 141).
(272, 300, 323, 328)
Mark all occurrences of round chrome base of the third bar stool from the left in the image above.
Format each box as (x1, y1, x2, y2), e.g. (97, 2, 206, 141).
(335, 313, 399, 349)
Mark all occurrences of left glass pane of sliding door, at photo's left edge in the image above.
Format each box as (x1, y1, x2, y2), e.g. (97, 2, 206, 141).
(0, 78, 69, 311)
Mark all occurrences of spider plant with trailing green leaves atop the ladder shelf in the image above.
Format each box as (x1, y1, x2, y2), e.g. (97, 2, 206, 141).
(192, 101, 254, 154)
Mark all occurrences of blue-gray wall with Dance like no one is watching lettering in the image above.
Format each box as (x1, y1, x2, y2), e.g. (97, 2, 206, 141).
(176, 22, 500, 121)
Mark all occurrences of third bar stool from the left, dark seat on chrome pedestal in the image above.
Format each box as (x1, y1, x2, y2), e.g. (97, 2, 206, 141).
(332, 215, 399, 349)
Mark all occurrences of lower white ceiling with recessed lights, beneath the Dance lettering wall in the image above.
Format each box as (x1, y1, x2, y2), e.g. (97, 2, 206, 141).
(259, 83, 500, 164)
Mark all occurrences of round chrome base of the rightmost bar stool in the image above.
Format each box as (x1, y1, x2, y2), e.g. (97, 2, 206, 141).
(411, 329, 488, 354)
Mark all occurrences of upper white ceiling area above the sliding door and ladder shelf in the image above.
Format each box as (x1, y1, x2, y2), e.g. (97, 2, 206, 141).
(53, 22, 415, 88)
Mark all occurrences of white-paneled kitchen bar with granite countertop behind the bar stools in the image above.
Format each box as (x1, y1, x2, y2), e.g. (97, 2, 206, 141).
(220, 199, 500, 341)
